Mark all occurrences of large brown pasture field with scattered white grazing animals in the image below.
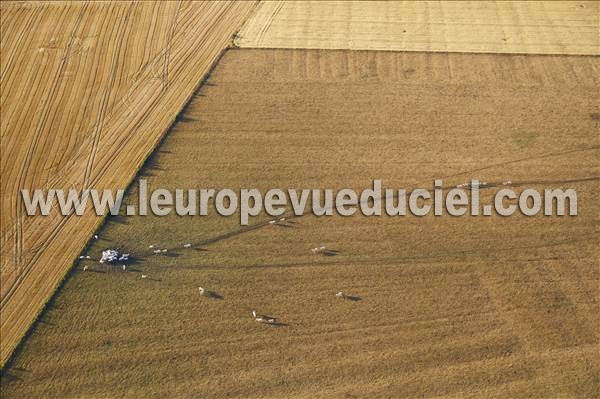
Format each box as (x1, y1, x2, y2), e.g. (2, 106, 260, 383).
(2, 50, 600, 398)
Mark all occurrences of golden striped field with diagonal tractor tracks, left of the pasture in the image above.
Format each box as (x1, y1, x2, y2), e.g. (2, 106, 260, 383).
(0, 1, 254, 364)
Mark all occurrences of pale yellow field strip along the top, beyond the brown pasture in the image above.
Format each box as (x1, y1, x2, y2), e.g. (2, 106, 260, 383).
(236, 1, 600, 55)
